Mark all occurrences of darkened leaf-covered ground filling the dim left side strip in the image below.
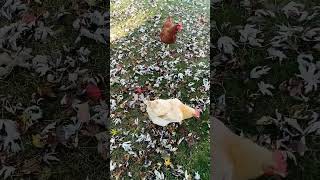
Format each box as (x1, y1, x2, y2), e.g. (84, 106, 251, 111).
(0, 0, 109, 179)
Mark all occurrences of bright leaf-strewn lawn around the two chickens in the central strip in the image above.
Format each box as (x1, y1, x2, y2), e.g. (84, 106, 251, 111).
(110, 0, 210, 179)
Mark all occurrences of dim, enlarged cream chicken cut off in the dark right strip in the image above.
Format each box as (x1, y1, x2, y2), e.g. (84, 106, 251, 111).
(212, 118, 287, 180)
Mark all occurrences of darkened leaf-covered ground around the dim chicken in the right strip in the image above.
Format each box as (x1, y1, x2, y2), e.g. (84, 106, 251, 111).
(211, 0, 320, 180)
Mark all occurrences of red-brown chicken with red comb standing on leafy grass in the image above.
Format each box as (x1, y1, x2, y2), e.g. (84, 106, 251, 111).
(160, 16, 182, 44)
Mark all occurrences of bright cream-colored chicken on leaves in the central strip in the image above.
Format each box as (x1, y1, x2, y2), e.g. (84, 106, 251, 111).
(145, 99, 200, 126)
